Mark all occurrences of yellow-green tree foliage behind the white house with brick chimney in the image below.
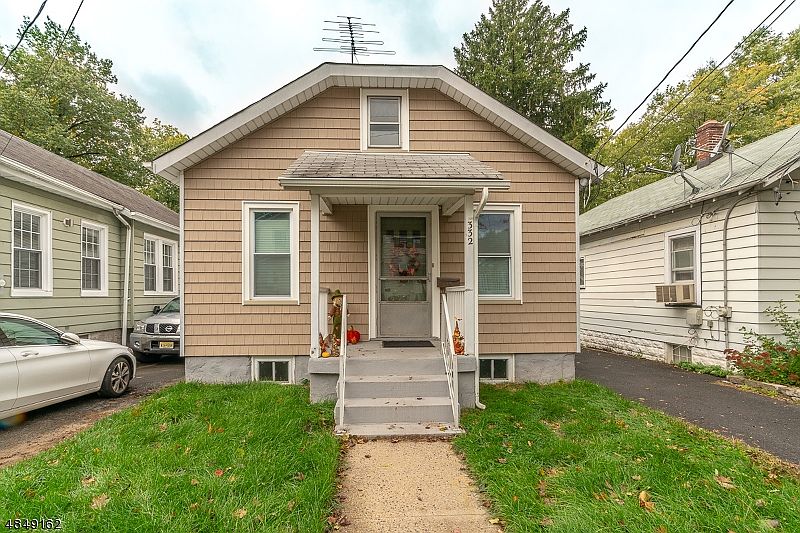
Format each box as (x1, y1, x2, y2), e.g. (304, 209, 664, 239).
(588, 28, 800, 209)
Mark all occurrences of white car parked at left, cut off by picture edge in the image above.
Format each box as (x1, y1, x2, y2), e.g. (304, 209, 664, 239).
(0, 313, 136, 419)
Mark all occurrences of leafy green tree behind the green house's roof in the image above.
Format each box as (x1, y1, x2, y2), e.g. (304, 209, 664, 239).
(0, 19, 186, 210)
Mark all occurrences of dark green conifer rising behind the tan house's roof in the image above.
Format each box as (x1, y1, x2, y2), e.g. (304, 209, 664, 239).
(453, 0, 613, 152)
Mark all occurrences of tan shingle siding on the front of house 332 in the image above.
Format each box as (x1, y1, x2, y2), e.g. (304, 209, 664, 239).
(184, 88, 576, 356)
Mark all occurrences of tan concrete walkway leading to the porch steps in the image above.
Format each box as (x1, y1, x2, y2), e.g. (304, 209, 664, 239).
(340, 440, 502, 533)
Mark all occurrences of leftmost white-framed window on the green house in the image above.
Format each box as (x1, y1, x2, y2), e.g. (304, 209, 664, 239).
(11, 202, 53, 296)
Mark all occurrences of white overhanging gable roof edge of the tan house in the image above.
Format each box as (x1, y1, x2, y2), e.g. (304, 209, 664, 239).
(153, 63, 602, 183)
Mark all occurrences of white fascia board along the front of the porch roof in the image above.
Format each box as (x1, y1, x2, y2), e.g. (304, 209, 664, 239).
(278, 178, 511, 194)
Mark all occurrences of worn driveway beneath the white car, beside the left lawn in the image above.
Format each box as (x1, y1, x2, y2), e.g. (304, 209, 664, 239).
(0, 356, 184, 468)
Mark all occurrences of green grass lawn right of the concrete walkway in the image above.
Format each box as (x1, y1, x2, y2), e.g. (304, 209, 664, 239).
(455, 381, 800, 533)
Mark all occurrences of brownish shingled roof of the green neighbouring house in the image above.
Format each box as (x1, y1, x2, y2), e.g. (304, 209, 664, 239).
(0, 130, 179, 229)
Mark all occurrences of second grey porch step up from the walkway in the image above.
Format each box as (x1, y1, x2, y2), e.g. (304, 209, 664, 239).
(335, 389, 454, 424)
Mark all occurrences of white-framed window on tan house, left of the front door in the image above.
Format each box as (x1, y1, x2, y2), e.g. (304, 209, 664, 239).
(242, 202, 300, 304)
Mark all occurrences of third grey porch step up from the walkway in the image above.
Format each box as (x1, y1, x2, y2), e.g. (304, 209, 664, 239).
(344, 374, 450, 399)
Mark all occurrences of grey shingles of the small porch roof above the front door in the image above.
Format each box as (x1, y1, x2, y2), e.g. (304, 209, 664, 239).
(283, 151, 503, 180)
